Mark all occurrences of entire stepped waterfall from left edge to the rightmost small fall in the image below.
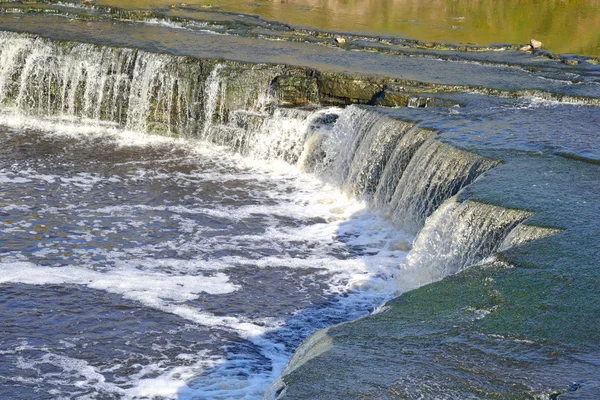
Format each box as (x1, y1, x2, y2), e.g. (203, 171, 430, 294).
(0, 32, 554, 296)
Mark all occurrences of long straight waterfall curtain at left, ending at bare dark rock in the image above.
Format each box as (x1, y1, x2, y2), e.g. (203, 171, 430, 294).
(0, 32, 284, 136)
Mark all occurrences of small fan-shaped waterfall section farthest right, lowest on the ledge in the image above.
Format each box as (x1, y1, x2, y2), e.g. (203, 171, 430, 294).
(401, 197, 532, 290)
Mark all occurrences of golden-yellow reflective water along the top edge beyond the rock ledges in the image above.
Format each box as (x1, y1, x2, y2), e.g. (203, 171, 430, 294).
(98, 0, 600, 55)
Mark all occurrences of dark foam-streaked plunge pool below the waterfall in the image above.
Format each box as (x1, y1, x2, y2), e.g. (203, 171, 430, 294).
(0, 119, 410, 399)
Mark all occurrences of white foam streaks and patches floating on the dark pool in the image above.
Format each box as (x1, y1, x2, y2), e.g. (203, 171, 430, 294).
(0, 113, 412, 399)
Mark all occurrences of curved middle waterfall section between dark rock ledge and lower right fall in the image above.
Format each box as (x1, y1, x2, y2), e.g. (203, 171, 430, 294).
(300, 106, 499, 233)
